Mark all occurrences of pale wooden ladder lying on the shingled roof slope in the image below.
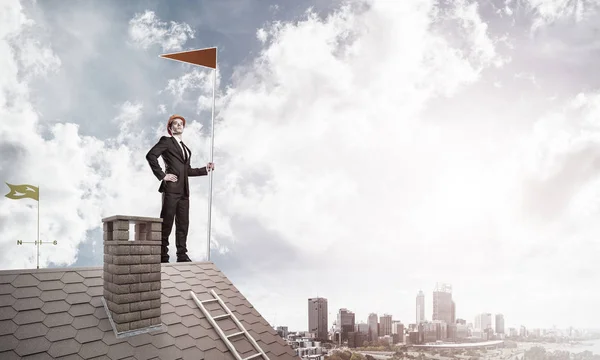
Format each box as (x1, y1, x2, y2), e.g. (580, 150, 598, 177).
(190, 289, 270, 360)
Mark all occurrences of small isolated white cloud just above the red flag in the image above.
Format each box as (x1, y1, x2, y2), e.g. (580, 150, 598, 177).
(129, 10, 194, 51)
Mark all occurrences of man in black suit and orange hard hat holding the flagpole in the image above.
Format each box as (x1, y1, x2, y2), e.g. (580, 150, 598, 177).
(146, 115, 214, 263)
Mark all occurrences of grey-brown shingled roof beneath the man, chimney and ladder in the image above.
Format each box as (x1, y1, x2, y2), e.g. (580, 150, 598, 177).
(0, 262, 298, 360)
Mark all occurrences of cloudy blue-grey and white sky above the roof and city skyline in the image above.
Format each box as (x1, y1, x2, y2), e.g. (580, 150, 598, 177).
(0, 0, 600, 331)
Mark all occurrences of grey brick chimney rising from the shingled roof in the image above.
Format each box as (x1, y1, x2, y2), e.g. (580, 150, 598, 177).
(102, 215, 162, 337)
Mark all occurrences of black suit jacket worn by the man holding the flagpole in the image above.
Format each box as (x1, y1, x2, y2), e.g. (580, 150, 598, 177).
(146, 136, 208, 196)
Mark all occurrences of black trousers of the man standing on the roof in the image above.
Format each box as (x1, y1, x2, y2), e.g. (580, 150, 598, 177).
(160, 192, 190, 261)
